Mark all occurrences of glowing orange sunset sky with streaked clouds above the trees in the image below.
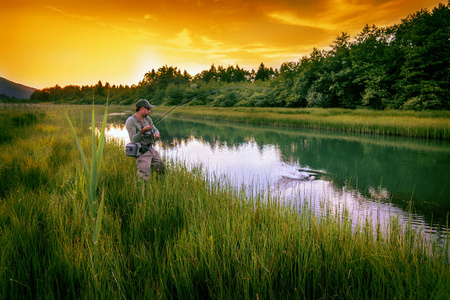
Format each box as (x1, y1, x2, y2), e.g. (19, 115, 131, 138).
(0, 0, 446, 88)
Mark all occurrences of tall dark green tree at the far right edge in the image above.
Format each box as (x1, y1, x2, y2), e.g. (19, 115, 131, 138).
(395, 2, 450, 109)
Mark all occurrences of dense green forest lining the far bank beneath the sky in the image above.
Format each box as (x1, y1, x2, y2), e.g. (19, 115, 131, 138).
(30, 1, 450, 110)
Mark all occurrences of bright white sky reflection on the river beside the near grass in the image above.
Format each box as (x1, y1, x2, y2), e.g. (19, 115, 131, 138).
(106, 120, 442, 240)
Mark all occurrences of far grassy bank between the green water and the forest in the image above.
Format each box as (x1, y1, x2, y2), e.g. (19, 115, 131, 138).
(155, 106, 450, 140)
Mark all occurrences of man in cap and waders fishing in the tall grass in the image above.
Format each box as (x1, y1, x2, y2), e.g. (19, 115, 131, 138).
(125, 99, 166, 181)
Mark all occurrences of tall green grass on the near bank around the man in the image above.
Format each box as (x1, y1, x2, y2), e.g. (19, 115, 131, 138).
(0, 106, 450, 299)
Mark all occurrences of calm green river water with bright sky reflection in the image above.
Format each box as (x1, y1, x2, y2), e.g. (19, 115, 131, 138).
(107, 115, 450, 235)
